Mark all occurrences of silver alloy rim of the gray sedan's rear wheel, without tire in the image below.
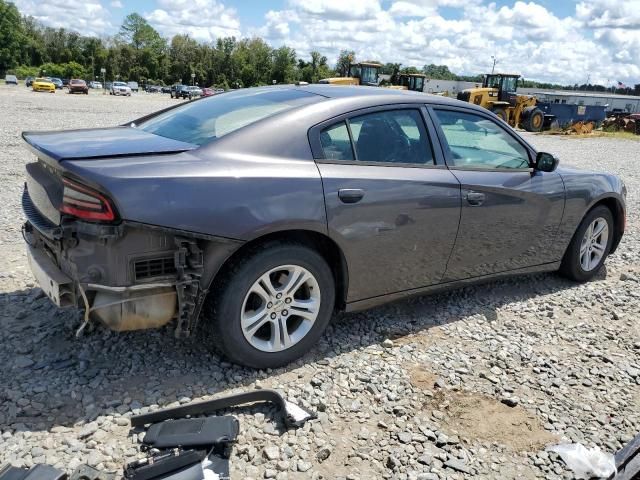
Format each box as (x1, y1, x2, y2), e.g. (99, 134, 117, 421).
(241, 265, 320, 352)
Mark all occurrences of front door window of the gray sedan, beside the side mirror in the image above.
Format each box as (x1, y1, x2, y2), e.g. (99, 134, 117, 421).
(435, 110, 529, 169)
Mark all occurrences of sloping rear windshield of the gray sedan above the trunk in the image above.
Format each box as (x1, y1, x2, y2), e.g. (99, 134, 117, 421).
(138, 87, 323, 145)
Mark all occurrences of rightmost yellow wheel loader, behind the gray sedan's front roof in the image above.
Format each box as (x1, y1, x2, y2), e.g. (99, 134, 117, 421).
(458, 73, 545, 132)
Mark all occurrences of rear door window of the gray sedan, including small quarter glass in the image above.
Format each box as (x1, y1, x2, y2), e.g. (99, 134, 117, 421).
(320, 109, 434, 165)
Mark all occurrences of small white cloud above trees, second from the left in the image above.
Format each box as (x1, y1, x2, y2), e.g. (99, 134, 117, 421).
(143, 0, 241, 42)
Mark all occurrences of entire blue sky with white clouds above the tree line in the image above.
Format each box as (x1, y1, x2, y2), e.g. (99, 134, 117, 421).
(14, 0, 640, 85)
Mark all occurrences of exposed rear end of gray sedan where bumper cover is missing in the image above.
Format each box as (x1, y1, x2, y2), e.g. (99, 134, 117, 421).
(23, 208, 242, 336)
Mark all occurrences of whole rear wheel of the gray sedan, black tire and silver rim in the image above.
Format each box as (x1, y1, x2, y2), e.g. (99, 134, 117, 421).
(205, 242, 335, 368)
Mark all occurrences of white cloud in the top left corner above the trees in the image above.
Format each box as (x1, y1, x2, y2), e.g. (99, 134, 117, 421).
(14, 0, 113, 36)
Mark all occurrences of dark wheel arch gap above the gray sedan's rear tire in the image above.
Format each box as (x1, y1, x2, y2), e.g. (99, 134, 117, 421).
(208, 229, 349, 309)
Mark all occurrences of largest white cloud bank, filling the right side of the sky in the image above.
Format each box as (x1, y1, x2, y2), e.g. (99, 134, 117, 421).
(254, 0, 640, 84)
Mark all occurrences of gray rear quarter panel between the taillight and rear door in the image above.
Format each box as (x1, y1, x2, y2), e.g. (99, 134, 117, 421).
(64, 152, 326, 240)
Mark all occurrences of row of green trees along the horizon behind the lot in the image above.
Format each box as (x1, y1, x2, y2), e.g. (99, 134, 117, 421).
(0, 0, 640, 95)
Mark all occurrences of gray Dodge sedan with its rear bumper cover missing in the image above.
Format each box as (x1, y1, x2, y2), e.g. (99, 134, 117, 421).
(22, 85, 626, 368)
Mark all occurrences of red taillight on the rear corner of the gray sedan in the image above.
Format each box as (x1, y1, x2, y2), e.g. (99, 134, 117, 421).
(60, 178, 116, 222)
